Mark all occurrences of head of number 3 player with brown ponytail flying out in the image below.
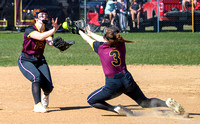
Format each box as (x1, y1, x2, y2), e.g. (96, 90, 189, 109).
(104, 25, 135, 47)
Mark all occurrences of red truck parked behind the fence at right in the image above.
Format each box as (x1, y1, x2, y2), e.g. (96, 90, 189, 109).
(133, 0, 200, 31)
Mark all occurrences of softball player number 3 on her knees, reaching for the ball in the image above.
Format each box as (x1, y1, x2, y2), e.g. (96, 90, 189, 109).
(79, 26, 184, 115)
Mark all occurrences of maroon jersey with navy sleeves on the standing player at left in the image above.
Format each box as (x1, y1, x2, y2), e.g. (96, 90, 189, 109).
(22, 25, 47, 56)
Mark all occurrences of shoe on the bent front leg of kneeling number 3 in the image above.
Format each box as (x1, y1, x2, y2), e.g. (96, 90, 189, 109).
(114, 105, 133, 116)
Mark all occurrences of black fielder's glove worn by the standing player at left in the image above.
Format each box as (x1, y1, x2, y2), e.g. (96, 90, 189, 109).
(53, 36, 75, 51)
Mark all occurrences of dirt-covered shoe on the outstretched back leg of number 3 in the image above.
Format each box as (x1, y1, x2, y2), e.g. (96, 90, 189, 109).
(166, 98, 185, 115)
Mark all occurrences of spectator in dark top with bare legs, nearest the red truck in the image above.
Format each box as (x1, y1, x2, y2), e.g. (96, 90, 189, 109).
(129, 0, 141, 28)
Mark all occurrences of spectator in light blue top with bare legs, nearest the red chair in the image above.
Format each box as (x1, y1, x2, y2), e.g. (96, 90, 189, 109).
(105, 0, 117, 25)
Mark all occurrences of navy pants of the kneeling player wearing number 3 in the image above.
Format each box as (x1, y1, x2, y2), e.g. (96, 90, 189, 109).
(87, 72, 167, 111)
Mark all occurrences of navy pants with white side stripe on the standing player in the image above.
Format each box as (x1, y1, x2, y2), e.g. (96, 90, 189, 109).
(18, 53, 53, 104)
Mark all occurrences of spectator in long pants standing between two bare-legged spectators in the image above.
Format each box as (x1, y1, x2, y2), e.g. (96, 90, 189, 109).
(117, 0, 128, 32)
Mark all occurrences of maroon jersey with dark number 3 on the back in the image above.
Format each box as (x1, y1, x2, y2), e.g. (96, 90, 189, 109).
(93, 41, 126, 75)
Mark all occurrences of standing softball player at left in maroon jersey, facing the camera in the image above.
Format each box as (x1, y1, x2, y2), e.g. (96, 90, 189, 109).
(18, 9, 61, 112)
